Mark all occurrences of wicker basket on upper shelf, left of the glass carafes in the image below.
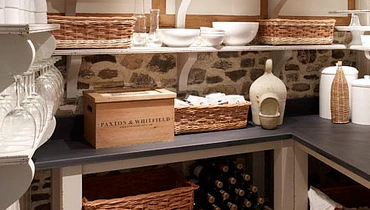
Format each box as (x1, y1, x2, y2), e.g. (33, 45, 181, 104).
(48, 15, 136, 48)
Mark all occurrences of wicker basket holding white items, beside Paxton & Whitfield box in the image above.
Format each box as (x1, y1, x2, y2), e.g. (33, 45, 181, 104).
(175, 101, 251, 134)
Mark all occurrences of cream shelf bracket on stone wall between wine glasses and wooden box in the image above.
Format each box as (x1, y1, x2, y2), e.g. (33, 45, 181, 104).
(66, 55, 82, 100)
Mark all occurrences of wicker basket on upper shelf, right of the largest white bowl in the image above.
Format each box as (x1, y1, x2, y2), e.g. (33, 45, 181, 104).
(257, 19, 335, 45)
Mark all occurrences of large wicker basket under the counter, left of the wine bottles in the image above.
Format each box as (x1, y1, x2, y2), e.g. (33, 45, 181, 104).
(82, 167, 198, 210)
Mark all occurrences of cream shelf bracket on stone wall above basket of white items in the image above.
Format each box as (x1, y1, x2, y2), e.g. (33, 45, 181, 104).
(177, 52, 197, 92)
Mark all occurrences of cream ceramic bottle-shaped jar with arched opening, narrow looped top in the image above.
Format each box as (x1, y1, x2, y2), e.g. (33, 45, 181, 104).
(249, 59, 287, 129)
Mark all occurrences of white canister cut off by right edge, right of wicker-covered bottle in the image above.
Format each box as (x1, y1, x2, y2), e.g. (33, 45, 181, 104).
(351, 75, 370, 125)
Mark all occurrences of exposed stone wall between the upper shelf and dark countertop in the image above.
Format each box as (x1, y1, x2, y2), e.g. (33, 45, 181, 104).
(58, 50, 356, 115)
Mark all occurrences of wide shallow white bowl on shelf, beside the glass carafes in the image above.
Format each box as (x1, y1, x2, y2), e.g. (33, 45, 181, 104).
(159, 28, 199, 47)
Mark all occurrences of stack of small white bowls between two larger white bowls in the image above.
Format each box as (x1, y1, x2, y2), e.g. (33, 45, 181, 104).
(200, 27, 225, 47)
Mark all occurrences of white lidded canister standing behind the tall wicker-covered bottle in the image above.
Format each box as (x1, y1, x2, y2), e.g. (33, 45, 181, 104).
(319, 66, 358, 120)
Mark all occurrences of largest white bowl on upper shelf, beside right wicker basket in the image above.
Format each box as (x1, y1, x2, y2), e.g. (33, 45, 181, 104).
(212, 22, 259, 46)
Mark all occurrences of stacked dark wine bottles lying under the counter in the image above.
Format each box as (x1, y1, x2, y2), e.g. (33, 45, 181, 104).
(189, 156, 265, 210)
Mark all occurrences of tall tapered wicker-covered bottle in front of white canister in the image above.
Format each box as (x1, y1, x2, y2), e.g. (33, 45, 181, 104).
(330, 64, 349, 124)
